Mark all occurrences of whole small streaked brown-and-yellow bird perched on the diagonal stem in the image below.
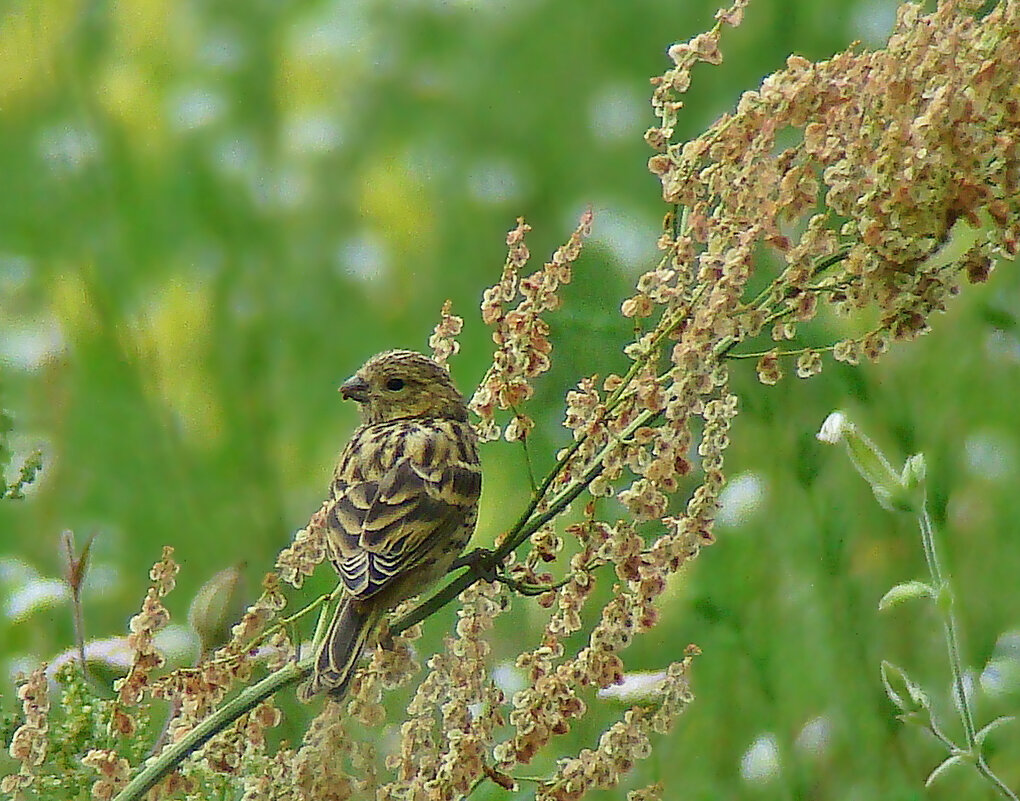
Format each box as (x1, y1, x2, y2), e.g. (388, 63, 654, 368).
(299, 350, 481, 701)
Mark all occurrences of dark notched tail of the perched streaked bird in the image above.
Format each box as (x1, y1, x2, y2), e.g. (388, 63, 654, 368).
(299, 596, 379, 701)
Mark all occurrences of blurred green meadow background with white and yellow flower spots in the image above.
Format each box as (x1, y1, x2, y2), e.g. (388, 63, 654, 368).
(0, 0, 1020, 799)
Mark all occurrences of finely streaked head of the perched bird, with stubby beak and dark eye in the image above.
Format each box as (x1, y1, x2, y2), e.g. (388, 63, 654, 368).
(340, 350, 467, 423)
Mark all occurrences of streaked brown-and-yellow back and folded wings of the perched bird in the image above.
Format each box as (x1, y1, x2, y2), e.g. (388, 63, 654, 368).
(329, 424, 481, 599)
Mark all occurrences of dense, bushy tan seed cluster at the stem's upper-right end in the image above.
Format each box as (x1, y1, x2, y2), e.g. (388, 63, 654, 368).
(648, 2, 1020, 384)
